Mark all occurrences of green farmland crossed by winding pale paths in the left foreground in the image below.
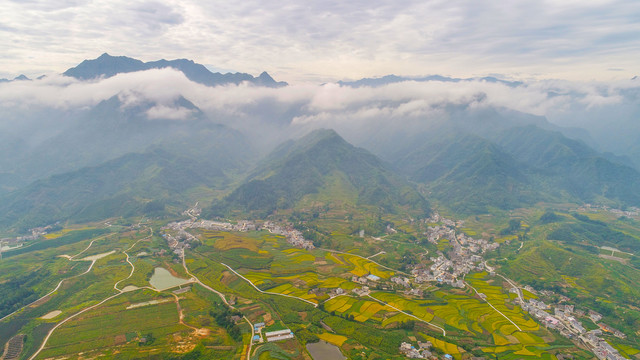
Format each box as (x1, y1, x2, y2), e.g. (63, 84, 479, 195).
(0, 225, 241, 358)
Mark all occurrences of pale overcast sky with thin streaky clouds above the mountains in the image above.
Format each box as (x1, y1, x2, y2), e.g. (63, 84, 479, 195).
(0, 0, 640, 83)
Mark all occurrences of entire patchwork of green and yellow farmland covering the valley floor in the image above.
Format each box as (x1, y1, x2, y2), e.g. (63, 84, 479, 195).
(0, 208, 636, 359)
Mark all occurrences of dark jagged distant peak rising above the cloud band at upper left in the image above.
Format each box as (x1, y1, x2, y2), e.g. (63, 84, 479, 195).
(63, 52, 287, 87)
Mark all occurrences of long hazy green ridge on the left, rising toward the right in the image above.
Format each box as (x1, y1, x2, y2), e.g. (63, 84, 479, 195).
(0, 127, 250, 229)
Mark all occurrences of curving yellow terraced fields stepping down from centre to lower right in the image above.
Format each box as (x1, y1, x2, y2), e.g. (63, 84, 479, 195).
(190, 229, 592, 359)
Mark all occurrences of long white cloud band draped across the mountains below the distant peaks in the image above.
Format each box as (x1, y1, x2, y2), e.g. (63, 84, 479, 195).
(0, 68, 640, 127)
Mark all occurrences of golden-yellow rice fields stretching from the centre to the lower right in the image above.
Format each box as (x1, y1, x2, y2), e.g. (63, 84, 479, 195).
(199, 233, 546, 358)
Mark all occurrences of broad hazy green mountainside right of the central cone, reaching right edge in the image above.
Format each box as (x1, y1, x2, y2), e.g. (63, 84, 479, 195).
(390, 125, 640, 214)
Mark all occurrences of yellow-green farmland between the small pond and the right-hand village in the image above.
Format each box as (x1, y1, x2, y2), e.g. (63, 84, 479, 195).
(190, 229, 584, 358)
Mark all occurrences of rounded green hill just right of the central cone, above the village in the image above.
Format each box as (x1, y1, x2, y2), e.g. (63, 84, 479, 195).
(397, 135, 541, 213)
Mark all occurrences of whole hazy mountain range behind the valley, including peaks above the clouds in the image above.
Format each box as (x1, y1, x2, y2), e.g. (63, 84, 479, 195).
(0, 54, 640, 230)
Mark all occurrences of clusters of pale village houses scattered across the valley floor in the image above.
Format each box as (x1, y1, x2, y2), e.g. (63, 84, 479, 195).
(163, 209, 626, 360)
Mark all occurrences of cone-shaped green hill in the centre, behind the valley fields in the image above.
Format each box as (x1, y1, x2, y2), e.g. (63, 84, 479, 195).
(210, 130, 428, 216)
